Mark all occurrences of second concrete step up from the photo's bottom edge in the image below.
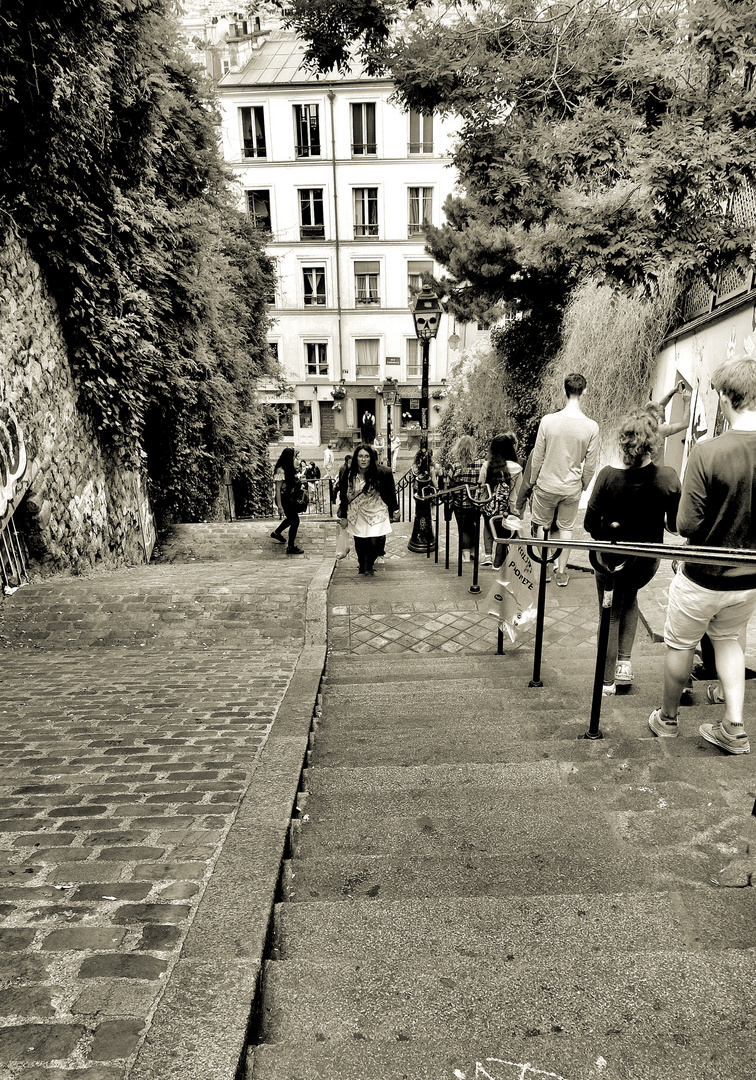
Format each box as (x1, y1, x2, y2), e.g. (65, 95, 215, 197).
(255, 948, 756, 1052)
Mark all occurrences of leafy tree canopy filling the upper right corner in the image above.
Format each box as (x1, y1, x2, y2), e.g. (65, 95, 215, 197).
(295, 0, 756, 318)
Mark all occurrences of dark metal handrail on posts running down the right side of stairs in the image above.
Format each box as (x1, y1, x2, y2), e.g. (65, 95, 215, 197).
(416, 485, 756, 740)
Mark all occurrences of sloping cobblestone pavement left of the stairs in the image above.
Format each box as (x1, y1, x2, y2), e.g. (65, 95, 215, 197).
(0, 522, 335, 1080)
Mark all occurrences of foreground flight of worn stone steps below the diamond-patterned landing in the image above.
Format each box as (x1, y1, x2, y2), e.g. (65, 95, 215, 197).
(246, 630, 756, 1080)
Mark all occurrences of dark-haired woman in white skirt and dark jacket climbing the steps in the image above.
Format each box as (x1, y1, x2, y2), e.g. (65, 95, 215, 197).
(338, 443, 399, 575)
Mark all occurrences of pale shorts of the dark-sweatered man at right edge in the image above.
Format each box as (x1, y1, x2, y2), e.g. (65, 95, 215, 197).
(664, 569, 756, 649)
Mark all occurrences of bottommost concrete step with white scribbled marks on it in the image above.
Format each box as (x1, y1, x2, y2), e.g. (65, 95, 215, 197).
(247, 1022, 756, 1080)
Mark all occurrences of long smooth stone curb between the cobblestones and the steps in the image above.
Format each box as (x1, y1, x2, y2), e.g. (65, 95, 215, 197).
(129, 555, 335, 1080)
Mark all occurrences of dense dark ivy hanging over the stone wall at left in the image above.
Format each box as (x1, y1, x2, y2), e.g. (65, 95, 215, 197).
(0, 0, 273, 519)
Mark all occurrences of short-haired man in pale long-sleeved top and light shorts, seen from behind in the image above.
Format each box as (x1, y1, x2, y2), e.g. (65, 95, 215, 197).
(530, 374, 598, 588)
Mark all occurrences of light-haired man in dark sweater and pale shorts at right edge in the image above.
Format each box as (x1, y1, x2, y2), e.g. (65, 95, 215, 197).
(648, 356, 756, 754)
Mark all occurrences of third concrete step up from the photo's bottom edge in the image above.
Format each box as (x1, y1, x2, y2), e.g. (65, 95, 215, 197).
(270, 889, 756, 961)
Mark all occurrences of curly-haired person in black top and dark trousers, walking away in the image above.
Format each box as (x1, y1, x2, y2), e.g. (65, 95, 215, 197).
(584, 410, 680, 694)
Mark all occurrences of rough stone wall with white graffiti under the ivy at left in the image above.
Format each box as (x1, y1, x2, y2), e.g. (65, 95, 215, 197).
(0, 232, 154, 572)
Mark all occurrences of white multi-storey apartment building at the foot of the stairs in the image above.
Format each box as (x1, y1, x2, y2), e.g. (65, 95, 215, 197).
(213, 30, 475, 449)
